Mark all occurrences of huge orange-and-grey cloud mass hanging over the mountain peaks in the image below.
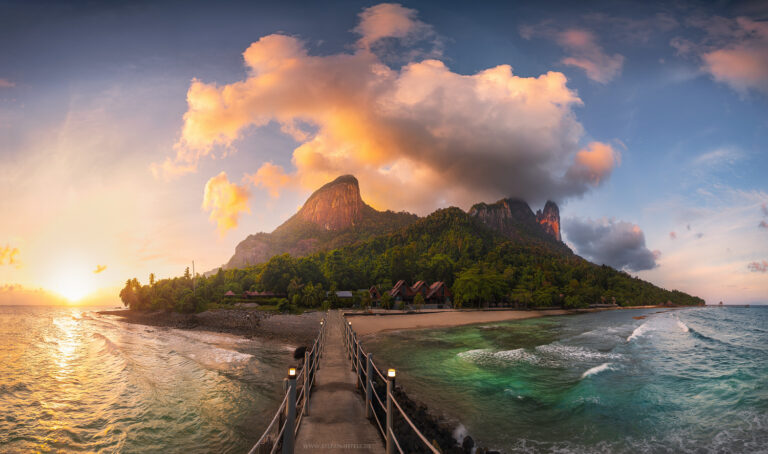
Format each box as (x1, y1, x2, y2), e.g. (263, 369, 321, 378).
(156, 5, 619, 212)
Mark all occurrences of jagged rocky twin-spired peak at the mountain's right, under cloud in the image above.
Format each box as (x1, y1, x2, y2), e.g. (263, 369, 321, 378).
(469, 199, 561, 242)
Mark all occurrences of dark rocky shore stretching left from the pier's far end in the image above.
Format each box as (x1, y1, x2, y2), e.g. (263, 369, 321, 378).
(96, 309, 322, 346)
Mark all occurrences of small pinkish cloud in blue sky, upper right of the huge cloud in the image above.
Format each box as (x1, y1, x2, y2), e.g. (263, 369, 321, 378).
(520, 24, 624, 84)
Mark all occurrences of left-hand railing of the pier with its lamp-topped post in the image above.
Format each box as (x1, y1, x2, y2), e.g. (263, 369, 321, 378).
(248, 317, 328, 454)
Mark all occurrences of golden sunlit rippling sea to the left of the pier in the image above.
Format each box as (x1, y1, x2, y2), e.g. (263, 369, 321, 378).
(0, 306, 295, 453)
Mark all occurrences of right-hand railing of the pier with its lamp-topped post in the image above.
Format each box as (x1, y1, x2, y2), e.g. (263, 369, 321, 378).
(343, 317, 440, 454)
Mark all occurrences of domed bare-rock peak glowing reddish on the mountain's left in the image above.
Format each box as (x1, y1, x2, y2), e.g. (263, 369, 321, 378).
(224, 175, 418, 268)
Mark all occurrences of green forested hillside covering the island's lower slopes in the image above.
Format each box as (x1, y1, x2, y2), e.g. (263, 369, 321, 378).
(120, 208, 704, 312)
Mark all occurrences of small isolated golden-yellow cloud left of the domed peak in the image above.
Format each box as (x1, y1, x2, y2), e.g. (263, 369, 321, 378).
(203, 172, 251, 235)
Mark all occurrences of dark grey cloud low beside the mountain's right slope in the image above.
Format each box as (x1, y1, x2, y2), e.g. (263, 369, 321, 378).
(563, 218, 661, 271)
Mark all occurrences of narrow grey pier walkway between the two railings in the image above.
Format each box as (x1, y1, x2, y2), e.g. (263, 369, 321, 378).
(295, 311, 384, 453)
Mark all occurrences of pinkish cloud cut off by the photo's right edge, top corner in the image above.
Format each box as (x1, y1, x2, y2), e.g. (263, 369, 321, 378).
(670, 16, 768, 94)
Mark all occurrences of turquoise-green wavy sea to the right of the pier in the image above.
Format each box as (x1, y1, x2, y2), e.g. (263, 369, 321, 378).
(365, 307, 768, 453)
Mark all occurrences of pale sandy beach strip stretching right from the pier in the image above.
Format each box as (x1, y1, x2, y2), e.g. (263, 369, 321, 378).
(345, 305, 680, 336)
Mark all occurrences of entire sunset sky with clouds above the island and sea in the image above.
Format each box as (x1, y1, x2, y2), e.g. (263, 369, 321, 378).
(0, 1, 768, 304)
